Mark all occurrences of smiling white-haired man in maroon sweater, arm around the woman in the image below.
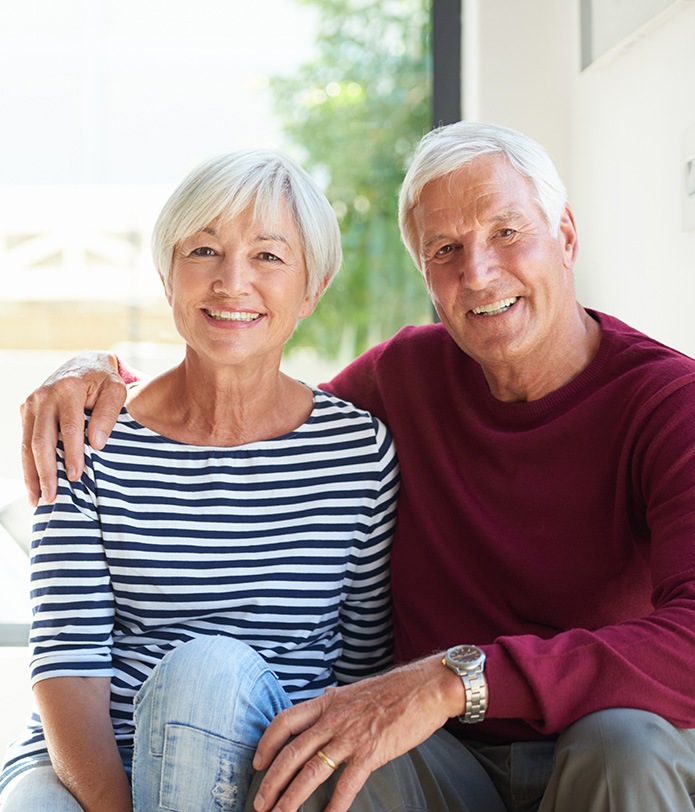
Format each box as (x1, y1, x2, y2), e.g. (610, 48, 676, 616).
(19, 122, 695, 812)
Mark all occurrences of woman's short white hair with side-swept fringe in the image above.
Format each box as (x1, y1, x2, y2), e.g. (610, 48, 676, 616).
(152, 149, 343, 294)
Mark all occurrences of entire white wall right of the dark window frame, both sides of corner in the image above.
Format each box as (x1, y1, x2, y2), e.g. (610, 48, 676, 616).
(463, 0, 695, 355)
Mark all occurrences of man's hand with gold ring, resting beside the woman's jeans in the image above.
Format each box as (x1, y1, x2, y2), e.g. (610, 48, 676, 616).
(253, 655, 465, 812)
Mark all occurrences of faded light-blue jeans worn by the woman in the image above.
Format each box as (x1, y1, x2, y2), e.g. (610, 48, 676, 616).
(0, 637, 291, 812)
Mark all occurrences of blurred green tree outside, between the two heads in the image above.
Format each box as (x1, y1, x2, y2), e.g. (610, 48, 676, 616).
(271, 0, 431, 358)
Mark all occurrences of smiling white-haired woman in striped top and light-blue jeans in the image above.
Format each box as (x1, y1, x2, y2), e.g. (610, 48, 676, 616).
(0, 151, 398, 812)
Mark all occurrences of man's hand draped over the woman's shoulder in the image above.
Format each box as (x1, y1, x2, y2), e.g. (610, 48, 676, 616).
(21, 352, 126, 507)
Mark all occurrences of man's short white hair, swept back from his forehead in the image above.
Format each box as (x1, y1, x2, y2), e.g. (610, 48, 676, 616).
(398, 121, 567, 267)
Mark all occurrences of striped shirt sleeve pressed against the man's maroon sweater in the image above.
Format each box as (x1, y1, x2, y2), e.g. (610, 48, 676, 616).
(334, 420, 399, 683)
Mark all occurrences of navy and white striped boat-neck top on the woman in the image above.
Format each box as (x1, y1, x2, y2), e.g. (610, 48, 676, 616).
(2, 390, 398, 763)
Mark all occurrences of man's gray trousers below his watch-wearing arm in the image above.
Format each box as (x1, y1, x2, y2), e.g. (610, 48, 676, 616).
(247, 708, 695, 812)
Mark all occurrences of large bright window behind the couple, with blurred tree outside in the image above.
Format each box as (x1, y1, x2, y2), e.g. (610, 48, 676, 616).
(0, 0, 431, 746)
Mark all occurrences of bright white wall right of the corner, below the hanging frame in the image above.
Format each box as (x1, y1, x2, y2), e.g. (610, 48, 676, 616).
(571, 0, 695, 355)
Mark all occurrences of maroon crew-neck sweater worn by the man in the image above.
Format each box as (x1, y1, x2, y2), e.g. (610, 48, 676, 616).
(325, 313, 695, 740)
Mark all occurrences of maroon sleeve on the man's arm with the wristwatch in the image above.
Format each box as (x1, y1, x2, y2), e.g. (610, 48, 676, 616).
(484, 382, 695, 734)
